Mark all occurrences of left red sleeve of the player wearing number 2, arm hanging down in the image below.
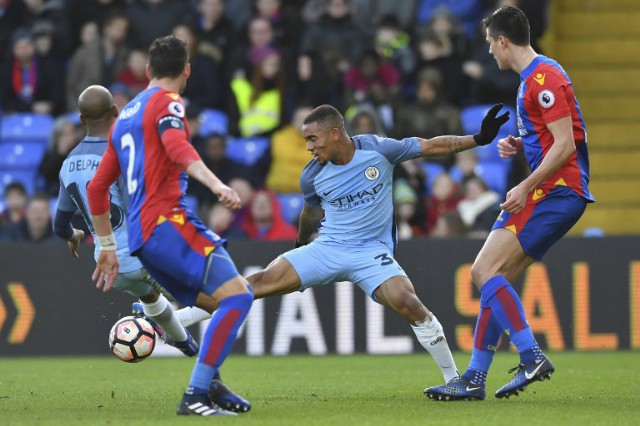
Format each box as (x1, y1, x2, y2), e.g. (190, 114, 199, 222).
(87, 135, 120, 215)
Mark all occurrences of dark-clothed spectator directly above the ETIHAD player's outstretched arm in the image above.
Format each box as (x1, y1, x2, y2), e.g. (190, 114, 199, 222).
(396, 68, 462, 167)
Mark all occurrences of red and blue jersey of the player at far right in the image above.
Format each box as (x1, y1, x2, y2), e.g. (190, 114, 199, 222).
(517, 55, 595, 202)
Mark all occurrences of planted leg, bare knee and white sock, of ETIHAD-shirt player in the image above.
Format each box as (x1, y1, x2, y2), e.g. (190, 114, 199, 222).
(375, 275, 458, 382)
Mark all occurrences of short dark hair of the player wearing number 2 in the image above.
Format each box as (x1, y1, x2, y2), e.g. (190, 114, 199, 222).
(149, 35, 189, 78)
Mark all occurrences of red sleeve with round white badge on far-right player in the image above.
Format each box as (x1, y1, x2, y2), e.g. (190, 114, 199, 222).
(530, 72, 571, 124)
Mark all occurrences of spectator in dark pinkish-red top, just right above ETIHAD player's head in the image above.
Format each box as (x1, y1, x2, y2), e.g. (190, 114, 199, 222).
(344, 48, 400, 129)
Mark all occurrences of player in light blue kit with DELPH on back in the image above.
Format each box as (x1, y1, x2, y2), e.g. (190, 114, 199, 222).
(54, 86, 210, 356)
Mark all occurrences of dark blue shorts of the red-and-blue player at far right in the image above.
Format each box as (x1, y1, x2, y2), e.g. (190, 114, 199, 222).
(491, 186, 587, 260)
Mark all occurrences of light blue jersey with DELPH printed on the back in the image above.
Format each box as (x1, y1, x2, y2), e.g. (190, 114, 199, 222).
(58, 136, 142, 272)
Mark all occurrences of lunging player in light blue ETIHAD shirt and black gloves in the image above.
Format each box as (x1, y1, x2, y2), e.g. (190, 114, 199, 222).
(247, 105, 509, 382)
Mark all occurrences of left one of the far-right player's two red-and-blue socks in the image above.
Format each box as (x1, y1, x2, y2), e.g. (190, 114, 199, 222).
(462, 297, 502, 386)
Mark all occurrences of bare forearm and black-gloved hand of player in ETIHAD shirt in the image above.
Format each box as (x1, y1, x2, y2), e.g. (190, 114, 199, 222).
(420, 104, 509, 157)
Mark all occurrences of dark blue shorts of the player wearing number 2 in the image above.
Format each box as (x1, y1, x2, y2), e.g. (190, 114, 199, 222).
(137, 211, 239, 306)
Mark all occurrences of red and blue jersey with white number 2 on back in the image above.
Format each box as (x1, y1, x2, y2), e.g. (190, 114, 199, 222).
(90, 87, 199, 254)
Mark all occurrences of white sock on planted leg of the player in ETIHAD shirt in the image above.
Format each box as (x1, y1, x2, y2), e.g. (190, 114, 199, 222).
(411, 315, 459, 382)
